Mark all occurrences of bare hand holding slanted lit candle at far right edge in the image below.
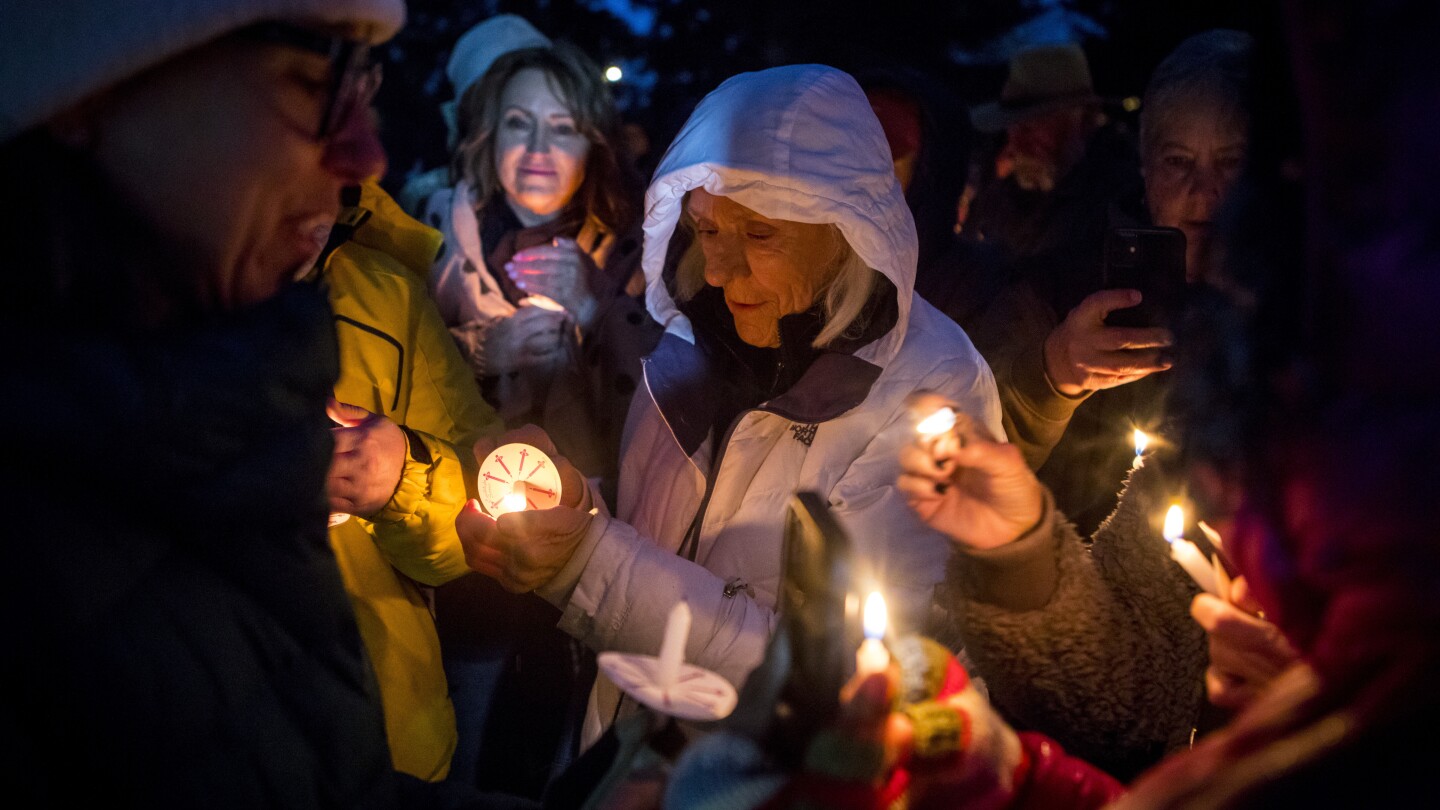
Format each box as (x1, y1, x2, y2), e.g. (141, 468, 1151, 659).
(1189, 577, 1297, 709)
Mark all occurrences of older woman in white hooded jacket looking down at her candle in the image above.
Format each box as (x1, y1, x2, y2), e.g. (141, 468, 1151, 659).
(459, 65, 1004, 742)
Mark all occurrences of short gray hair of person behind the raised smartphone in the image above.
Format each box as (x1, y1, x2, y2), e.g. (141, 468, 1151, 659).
(1140, 29, 1254, 156)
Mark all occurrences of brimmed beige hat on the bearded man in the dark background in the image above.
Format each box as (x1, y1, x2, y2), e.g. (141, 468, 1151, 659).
(971, 43, 1103, 133)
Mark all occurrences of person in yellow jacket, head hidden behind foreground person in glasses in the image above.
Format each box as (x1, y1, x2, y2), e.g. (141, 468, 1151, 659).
(320, 182, 501, 781)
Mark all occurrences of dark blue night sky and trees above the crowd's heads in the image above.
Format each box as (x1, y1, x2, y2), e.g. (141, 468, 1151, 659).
(377, 0, 1274, 190)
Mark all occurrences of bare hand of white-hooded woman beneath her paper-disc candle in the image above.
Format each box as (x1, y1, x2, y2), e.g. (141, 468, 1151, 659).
(455, 500, 595, 594)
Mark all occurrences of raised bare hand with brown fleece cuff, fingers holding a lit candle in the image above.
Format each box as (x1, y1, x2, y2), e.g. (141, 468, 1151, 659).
(899, 393, 1044, 549)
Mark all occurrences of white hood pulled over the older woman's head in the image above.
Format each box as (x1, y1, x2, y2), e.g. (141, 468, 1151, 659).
(642, 65, 917, 366)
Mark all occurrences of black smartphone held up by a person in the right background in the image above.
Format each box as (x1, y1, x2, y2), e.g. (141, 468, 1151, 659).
(1103, 228, 1185, 329)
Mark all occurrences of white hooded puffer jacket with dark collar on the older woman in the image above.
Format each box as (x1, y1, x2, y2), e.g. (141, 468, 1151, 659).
(541, 65, 1004, 745)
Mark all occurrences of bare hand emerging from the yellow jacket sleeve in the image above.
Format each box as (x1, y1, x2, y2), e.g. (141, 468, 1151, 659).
(325, 398, 405, 517)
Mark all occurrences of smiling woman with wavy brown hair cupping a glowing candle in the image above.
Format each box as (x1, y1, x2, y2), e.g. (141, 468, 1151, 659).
(416, 35, 660, 490)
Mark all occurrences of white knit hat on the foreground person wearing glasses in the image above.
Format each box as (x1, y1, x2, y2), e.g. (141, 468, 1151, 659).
(0, 0, 405, 143)
